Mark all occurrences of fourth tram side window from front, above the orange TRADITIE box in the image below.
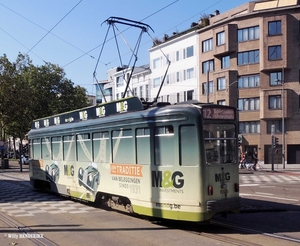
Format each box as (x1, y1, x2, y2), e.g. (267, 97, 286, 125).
(112, 129, 134, 164)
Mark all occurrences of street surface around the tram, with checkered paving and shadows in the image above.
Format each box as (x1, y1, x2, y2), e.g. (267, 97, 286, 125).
(0, 162, 300, 246)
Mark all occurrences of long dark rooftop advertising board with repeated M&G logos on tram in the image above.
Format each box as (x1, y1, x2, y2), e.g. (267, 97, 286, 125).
(31, 97, 143, 129)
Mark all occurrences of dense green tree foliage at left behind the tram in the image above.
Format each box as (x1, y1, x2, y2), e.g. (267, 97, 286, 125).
(0, 54, 88, 139)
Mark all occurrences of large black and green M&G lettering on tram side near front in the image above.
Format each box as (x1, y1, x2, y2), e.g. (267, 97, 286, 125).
(152, 171, 184, 189)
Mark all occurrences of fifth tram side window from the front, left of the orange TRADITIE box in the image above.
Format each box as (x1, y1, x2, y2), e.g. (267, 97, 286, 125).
(93, 132, 110, 163)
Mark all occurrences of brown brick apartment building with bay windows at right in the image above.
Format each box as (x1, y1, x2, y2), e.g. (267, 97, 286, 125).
(198, 0, 300, 166)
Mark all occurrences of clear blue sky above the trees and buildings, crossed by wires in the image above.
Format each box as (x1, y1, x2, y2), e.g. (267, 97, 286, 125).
(0, 0, 250, 95)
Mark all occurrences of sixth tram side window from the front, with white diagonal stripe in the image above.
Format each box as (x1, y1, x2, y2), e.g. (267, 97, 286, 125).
(76, 133, 92, 161)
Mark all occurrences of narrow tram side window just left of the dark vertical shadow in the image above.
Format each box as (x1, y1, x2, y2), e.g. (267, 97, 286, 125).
(136, 128, 150, 164)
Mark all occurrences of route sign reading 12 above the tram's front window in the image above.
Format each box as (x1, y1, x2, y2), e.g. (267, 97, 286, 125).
(202, 107, 235, 120)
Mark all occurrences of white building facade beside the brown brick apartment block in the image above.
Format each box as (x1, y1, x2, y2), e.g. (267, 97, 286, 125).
(149, 30, 199, 103)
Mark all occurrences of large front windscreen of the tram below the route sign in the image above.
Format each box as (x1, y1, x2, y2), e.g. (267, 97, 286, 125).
(203, 124, 237, 165)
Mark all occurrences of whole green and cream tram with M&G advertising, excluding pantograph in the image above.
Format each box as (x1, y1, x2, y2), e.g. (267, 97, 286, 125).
(28, 97, 241, 222)
